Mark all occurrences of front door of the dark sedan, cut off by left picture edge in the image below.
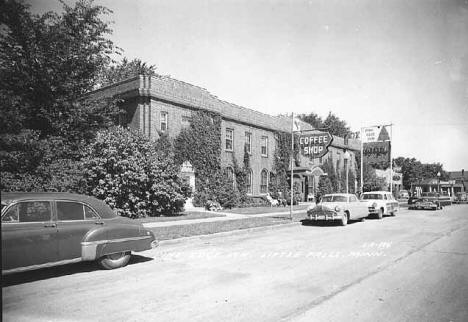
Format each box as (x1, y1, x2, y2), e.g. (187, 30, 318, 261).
(2, 200, 58, 270)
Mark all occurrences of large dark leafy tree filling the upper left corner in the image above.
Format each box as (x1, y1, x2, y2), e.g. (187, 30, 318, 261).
(0, 0, 119, 137)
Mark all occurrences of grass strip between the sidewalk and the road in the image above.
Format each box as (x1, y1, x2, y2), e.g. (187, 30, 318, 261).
(148, 214, 305, 240)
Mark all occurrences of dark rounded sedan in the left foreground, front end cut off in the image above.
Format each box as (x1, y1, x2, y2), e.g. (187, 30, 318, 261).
(1, 192, 158, 274)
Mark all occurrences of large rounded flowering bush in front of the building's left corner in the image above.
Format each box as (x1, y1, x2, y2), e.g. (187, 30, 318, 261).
(83, 127, 189, 218)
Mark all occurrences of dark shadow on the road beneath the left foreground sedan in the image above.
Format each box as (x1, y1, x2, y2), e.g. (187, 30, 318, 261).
(2, 254, 154, 288)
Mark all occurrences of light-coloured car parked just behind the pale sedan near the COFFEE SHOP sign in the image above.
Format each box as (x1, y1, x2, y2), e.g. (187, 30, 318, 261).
(361, 191, 400, 219)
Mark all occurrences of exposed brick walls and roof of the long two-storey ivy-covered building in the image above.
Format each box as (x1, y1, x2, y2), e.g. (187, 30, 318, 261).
(91, 75, 360, 200)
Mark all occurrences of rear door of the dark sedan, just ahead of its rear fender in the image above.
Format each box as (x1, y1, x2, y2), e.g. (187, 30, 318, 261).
(56, 200, 104, 260)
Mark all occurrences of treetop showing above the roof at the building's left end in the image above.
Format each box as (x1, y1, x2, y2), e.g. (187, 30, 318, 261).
(98, 58, 156, 86)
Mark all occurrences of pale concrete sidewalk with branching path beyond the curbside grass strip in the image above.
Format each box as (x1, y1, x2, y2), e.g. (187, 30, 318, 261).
(143, 208, 306, 228)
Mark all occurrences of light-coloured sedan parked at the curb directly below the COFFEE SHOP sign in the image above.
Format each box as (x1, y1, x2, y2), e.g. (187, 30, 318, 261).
(306, 193, 368, 226)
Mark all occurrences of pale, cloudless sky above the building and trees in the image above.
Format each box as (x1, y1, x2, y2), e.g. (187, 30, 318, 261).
(29, 0, 468, 171)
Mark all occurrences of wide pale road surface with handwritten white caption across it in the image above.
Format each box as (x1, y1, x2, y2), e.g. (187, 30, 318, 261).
(2, 205, 468, 322)
